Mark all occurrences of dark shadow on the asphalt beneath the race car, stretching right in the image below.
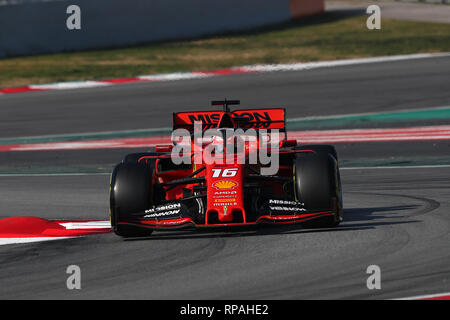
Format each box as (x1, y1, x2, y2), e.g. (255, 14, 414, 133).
(125, 205, 419, 241)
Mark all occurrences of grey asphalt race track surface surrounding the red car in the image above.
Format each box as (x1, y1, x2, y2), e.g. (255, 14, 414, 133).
(0, 57, 450, 299)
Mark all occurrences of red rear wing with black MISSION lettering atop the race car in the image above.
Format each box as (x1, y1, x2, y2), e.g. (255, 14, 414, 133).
(173, 108, 286, 132)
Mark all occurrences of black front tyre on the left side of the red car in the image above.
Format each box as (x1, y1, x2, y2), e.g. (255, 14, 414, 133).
(110, 162, 153, 237)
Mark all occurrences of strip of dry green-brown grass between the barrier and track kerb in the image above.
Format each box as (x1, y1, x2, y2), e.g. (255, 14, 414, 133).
(0, 14, 450, 87)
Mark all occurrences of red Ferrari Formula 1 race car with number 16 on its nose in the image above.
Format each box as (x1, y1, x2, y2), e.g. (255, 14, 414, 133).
(110, 100, 343, 237)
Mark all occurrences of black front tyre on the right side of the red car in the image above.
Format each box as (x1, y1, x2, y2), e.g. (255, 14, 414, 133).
(294, 153, 342, 228)
